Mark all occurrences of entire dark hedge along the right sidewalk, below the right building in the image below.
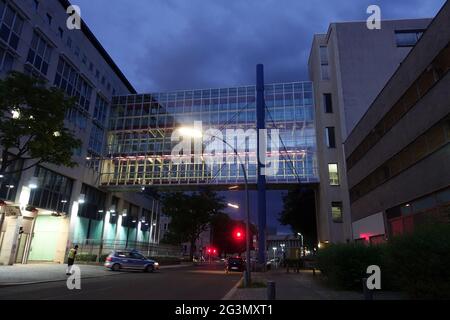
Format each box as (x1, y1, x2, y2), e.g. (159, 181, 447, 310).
(317, 224, 450, 299)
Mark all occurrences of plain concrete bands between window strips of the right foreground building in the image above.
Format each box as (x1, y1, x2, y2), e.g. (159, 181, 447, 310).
(345, 2, 450, 219)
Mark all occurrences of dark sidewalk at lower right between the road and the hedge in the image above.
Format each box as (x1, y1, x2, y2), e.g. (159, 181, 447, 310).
(227, 269, 405, 300)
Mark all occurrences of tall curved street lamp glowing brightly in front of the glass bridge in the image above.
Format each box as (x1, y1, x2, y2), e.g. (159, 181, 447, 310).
(178, 127, 251, 286)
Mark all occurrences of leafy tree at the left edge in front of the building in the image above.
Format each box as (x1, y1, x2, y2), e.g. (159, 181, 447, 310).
(0, 72, 81, 174)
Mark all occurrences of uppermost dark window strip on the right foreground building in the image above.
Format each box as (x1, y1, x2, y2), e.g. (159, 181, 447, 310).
(347, 43, 450, 170)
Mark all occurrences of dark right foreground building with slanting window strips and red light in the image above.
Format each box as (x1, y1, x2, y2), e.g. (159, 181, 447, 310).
(345, 2, 450, 241)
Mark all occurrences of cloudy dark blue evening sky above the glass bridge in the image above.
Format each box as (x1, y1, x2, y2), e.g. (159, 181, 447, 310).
(72, 0, 445, 235)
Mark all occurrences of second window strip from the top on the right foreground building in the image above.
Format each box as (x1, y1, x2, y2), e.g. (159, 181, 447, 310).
(350, 116, 450, 202)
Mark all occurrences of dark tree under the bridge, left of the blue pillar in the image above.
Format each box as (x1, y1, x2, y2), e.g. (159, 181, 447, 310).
(161, 190, 226, 260)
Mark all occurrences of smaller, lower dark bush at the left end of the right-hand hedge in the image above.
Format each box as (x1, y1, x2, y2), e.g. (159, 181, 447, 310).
(317, 244, 384, 290)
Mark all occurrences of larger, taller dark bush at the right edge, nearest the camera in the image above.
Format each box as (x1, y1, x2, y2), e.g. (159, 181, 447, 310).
(382, 224, 450, 299)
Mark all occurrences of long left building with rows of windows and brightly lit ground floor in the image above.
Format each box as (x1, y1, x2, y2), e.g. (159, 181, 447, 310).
(0, 0, 160, 264)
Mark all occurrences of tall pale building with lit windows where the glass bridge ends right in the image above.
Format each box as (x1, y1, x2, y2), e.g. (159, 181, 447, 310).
(309, 19, 431, 243)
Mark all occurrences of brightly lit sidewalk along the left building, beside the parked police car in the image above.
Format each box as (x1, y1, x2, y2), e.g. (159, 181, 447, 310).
(0, 263, 188, 288)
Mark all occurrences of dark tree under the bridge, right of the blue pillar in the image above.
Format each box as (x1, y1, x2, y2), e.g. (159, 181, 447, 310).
(278, 186, 317, 246)
